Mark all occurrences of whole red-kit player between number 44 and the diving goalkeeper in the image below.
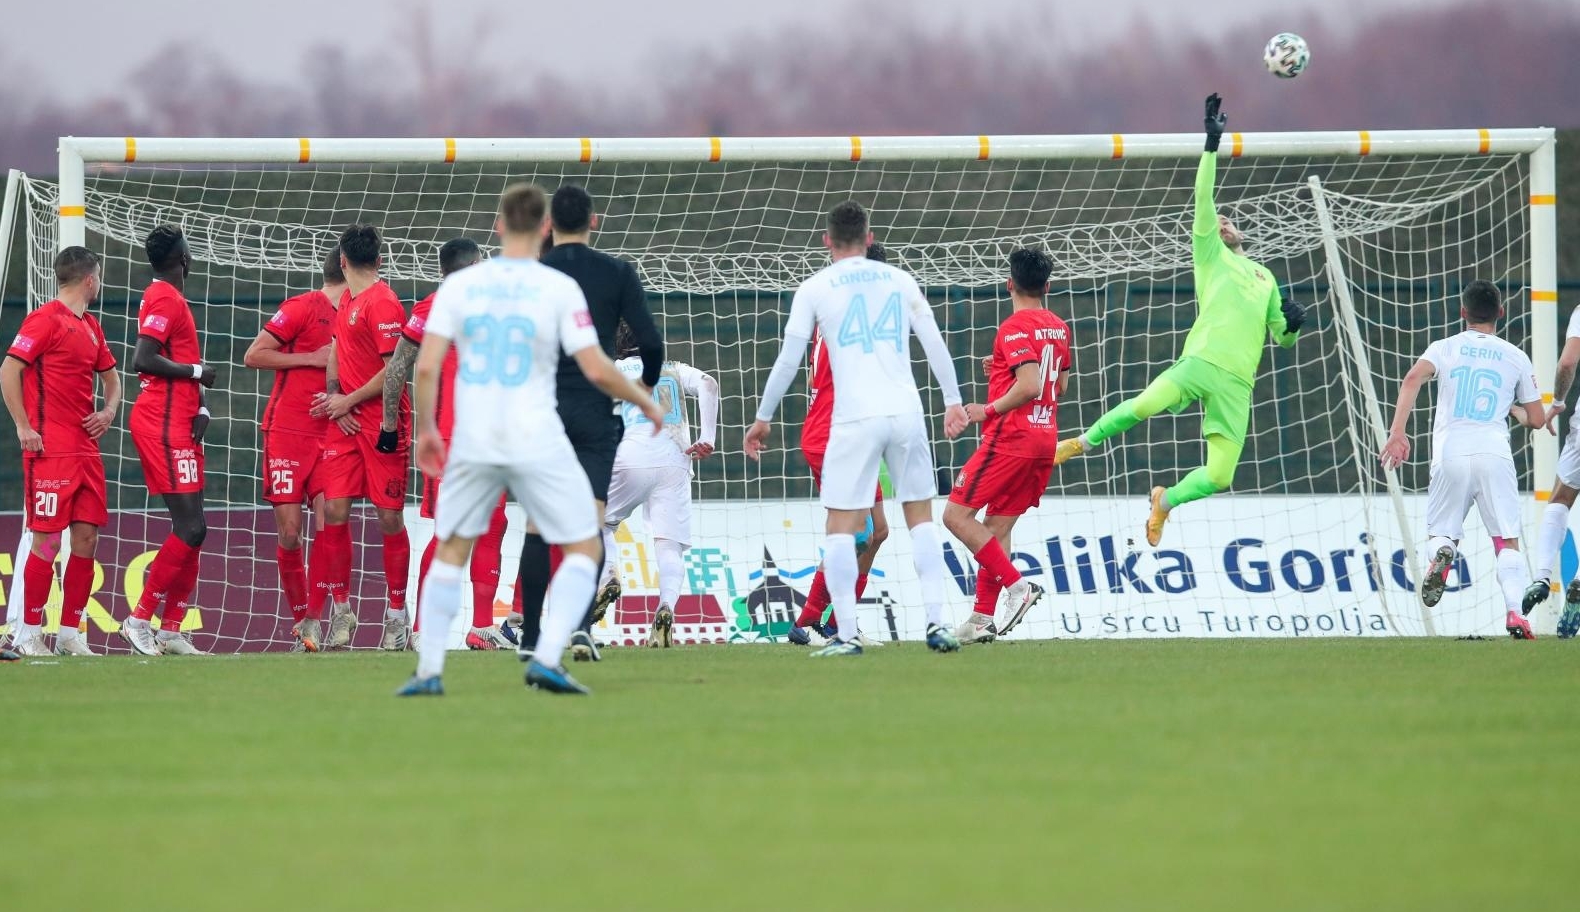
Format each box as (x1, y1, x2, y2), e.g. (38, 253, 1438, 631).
(943, 248, 1070, 643)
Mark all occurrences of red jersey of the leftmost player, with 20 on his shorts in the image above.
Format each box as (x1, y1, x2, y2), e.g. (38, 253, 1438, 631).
(6, 300, 115, 460)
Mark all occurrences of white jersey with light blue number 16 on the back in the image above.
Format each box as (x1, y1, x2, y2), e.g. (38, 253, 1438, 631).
(1420, 330, 1542, 468)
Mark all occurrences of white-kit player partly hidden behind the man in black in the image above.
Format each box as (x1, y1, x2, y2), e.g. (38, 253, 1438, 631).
(599, 322, 719, 650)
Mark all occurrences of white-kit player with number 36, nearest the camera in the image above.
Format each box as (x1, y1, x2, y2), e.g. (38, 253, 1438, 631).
(397, 183, 664, 697)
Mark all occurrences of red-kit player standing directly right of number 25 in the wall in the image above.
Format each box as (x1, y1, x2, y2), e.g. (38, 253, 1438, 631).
(313, 224, 411, 650)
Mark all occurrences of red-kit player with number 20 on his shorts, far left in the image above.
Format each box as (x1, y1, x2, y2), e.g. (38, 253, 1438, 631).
(0, 247, 120, 656)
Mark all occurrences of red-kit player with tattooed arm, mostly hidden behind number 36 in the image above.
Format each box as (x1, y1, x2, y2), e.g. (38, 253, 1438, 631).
(379, 237, 510, 650)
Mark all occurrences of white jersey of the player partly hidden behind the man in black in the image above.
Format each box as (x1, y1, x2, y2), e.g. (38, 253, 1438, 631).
(615, 357, 719, 471)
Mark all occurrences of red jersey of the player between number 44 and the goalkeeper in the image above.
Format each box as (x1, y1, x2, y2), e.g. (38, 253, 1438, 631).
(983, 308, 1070, 457)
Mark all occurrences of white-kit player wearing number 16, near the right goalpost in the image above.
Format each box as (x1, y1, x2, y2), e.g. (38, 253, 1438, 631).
(1381, 281, 1547, 640)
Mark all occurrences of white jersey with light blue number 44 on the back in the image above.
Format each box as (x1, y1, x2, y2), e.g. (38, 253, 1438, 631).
(785, 256, 931, 424)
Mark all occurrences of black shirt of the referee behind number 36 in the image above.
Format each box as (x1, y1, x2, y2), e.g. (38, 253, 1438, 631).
(544, 243, 664, 413)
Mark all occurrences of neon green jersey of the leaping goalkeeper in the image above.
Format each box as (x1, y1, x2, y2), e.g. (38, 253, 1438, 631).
(1180, 152, 1296, 384)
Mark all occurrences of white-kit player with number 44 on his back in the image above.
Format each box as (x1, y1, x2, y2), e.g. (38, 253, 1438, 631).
(746, 201, 970, 658)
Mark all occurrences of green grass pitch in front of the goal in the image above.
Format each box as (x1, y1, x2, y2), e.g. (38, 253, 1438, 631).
(0, 640, 1580, 912)
